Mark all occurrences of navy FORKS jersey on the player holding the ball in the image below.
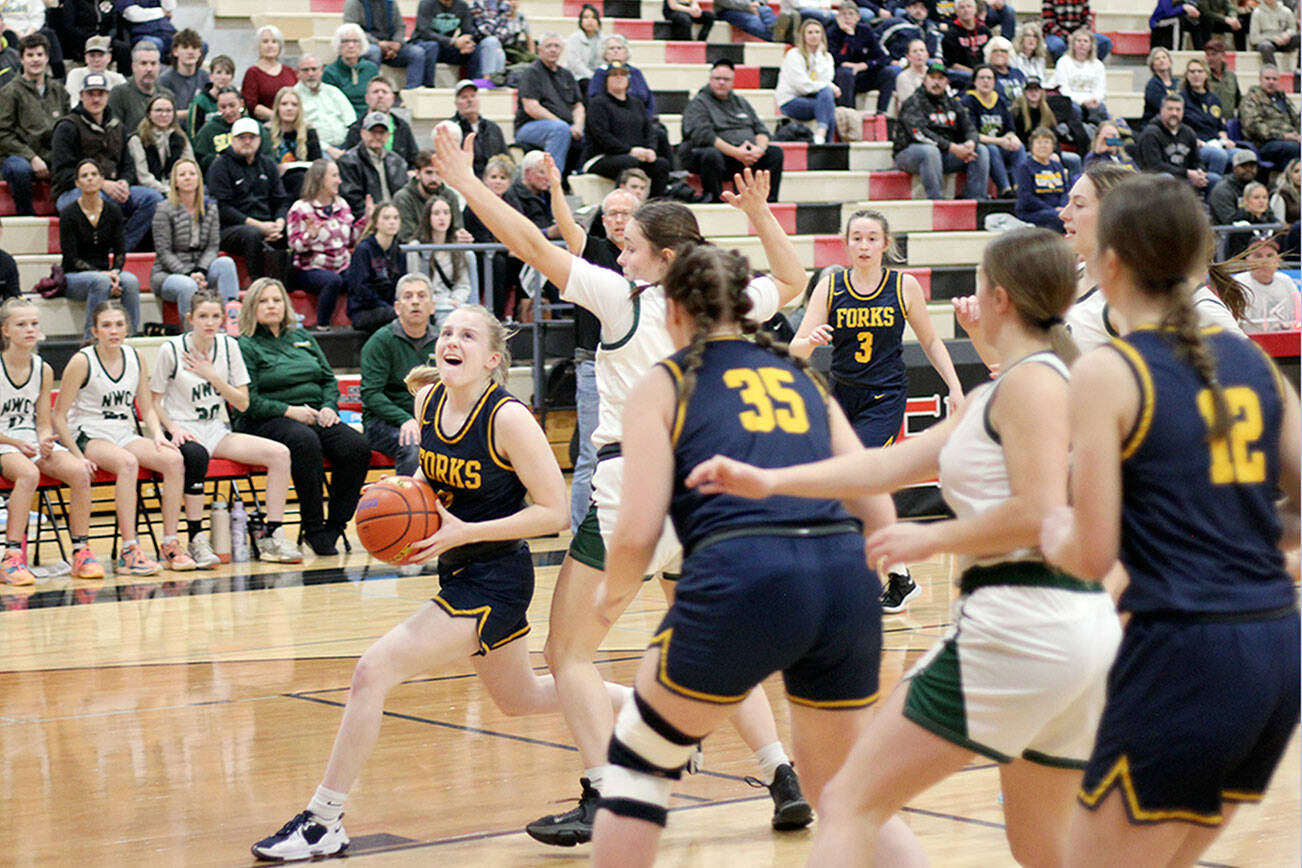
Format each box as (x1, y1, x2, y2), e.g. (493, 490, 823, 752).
(417, 383, 526, 522)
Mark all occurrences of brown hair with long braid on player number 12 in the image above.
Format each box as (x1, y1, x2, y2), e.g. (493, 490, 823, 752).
(1099, 174, 1230, 441)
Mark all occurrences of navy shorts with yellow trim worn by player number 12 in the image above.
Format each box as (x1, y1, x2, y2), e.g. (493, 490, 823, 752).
(1079, 610, 1302, 826)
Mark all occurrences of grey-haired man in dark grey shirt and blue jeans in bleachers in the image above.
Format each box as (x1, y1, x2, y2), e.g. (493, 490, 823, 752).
(516, 33, 586, 180)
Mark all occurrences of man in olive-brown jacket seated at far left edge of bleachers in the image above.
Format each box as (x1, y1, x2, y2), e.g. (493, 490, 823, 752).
(0, 33, 68, 216)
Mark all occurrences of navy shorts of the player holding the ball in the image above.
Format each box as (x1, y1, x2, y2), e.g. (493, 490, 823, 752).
(434, 543, 534, 655)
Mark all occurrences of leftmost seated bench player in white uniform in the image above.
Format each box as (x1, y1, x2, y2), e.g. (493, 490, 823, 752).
(0, 297, 104, 584)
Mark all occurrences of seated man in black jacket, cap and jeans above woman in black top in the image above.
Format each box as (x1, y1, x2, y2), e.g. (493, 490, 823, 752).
(49, 73, 163, 250)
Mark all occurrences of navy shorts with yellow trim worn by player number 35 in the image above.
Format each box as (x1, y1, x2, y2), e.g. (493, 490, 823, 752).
(651, 532, 881, 708)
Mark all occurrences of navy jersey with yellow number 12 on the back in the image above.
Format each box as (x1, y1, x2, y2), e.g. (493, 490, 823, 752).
(1112, 328, 1294, 614)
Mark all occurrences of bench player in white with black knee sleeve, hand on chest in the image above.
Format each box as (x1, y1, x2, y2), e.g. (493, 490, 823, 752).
(150, 290, 303, 570)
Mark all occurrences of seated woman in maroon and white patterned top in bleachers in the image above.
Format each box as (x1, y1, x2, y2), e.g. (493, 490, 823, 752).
(285, 160, 361, 331)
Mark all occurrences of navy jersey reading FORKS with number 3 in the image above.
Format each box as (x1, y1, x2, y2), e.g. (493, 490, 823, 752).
(827, 268, 909, 389)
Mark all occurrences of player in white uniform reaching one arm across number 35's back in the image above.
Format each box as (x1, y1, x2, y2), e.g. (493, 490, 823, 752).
(687, 229, 1121, 865)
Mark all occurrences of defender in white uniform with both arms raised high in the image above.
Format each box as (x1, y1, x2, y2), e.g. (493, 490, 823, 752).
(435, 122, 828, 846)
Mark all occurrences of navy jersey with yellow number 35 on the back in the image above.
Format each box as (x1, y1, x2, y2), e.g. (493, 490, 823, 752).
(660, 337, 850, 552)
